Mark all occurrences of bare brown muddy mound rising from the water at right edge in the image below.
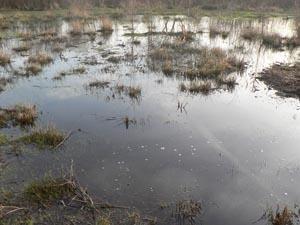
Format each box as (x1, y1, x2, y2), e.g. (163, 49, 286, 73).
(259, 62, 300, 98)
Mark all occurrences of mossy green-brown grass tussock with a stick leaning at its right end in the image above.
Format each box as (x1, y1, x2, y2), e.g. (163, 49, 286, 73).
(19, 126, 65, 148)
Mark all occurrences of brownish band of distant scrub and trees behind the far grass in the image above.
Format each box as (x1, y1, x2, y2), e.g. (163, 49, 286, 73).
(0, 0, 300, 10)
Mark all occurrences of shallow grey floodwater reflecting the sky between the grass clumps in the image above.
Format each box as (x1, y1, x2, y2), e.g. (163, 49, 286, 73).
(0, 16, 300, 225)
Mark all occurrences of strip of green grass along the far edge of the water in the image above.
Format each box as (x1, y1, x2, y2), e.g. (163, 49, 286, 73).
(0, 7, 298, 21)
